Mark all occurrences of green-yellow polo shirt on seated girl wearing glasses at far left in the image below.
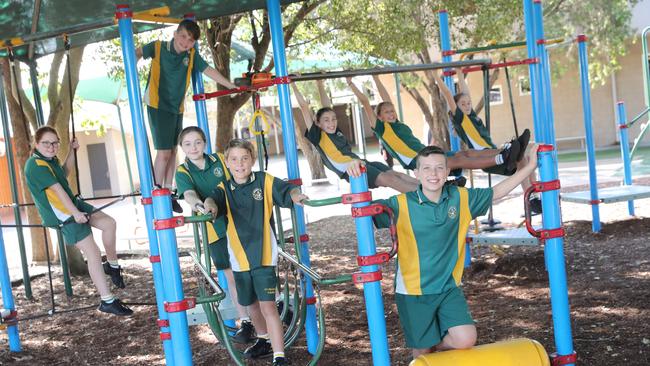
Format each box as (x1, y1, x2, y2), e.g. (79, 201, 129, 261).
(25, 151, 77, 227)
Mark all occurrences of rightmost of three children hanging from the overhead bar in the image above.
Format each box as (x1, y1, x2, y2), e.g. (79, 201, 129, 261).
(433, 68, 542, 214)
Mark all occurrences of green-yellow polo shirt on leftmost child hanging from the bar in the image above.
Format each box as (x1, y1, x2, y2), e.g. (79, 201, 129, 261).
(305, 123, 360, 178)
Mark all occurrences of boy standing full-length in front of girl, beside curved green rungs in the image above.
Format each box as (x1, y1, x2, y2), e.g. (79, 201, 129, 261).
(204, 139, 307, 366)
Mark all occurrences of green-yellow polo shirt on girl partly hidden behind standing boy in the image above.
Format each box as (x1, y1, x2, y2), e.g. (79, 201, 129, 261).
(175, 153, 230, 244)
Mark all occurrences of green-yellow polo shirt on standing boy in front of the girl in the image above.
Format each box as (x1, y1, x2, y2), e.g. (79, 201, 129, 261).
(211, 172, 297, 272)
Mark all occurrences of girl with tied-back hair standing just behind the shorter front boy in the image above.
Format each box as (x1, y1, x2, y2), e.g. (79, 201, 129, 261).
(176, 126, 255, 343)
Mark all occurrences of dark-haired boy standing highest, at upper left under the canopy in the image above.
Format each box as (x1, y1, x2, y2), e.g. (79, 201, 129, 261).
(135, 19, 235, 212)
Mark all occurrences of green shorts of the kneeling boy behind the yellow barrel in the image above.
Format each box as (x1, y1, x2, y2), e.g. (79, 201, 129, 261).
(395, 287, 474, 349)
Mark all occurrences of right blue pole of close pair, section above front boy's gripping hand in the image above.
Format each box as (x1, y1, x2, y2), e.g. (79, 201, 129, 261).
(533, 0, 555, 146)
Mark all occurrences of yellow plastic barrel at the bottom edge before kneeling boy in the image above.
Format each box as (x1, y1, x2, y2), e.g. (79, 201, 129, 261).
(409, 338, 551, 366)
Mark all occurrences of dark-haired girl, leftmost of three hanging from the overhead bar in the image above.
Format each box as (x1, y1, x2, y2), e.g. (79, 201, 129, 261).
(291, 81, 417, 192)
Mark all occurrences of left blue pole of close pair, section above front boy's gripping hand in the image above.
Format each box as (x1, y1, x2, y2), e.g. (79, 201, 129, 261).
(524, 0, 545, 142)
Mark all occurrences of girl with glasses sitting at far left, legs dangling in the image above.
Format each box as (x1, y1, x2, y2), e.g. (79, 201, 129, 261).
(25, 126, 133, 315)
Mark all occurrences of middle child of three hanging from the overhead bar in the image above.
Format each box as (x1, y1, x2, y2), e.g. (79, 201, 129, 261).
(346, 74, 520, 180)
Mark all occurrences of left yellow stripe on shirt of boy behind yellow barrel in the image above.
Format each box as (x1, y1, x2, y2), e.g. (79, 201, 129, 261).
(397, 194, 422, 295)
